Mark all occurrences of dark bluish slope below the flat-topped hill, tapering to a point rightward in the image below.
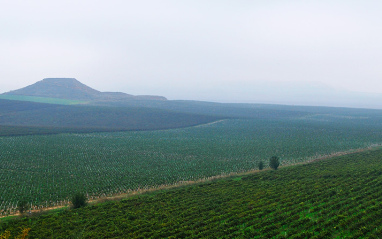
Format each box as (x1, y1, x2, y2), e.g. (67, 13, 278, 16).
(0, 100, 221, 135)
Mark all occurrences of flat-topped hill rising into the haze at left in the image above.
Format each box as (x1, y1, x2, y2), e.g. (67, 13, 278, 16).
(4, 78, 167, 101)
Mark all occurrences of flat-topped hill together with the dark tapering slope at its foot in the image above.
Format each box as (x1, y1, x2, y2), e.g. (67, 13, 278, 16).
(0, 78, 230, 135)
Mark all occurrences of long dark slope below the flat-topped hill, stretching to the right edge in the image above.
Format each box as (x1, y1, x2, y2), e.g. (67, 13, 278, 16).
(0, 98, 382, 136)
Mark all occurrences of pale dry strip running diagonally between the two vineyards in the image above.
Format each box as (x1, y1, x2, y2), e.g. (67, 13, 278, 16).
(0, 145, 382, 218)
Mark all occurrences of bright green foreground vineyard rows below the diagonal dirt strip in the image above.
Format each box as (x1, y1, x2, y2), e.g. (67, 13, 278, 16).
(0, 150, 382, 238)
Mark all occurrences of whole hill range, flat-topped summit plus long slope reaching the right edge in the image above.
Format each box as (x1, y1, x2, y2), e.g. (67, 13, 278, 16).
(0, 78, 381, 135)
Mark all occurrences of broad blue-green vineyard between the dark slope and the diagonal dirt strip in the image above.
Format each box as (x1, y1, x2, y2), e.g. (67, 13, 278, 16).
(0, 115, 382, 216)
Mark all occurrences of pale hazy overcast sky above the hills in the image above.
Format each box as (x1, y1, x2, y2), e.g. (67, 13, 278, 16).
(0, 0, 382, 105)
